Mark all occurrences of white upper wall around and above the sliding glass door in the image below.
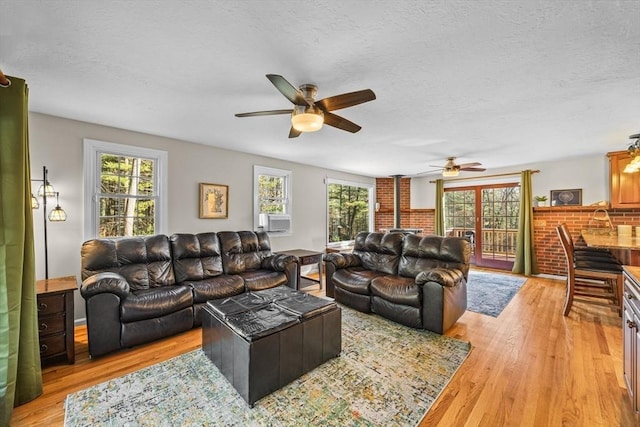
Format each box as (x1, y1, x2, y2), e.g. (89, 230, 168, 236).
(411, 153, 609, 209)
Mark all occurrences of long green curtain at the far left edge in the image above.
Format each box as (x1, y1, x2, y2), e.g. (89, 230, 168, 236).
(0, 76, 42, 426)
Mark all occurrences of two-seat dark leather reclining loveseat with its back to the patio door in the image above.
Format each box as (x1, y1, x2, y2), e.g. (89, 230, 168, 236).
(324, 232, 471, 334)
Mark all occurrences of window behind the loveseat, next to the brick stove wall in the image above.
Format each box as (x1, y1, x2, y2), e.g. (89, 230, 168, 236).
(327, 179, 374, 243)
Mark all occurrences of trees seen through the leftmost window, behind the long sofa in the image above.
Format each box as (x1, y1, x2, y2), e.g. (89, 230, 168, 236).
(98, 154, 156, 237)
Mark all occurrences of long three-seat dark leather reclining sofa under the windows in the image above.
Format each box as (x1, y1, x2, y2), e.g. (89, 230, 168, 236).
(80, 231, 298, 357)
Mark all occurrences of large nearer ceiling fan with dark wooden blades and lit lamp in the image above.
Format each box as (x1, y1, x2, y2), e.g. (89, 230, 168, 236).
(236, 74, 376, 138)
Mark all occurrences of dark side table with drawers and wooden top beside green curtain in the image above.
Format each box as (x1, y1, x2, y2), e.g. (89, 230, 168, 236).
(36, 276, 78, 366)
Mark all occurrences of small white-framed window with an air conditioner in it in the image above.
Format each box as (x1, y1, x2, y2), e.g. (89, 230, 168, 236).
(253, 165, 293, 232)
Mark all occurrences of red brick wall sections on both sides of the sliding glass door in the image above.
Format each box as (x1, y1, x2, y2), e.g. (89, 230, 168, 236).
(374, 178, 640, 276)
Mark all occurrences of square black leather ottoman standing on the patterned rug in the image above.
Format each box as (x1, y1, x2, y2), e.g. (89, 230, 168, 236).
(202, 286, 342, 406)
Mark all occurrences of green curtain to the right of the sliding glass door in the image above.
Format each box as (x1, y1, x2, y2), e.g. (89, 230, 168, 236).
(511, 170, 539, 276)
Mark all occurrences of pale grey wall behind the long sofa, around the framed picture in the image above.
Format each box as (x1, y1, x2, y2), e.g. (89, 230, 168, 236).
(29, 113, 375, 319)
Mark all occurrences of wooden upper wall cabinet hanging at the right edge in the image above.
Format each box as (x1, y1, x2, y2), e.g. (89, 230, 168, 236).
(607, 151, 640, 208)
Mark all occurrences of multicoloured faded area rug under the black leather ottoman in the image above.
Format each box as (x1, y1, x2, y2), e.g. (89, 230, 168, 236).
(65, 307, 471, 426)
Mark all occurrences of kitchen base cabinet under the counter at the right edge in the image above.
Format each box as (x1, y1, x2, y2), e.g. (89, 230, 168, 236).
(622, 266, 640, 412)
